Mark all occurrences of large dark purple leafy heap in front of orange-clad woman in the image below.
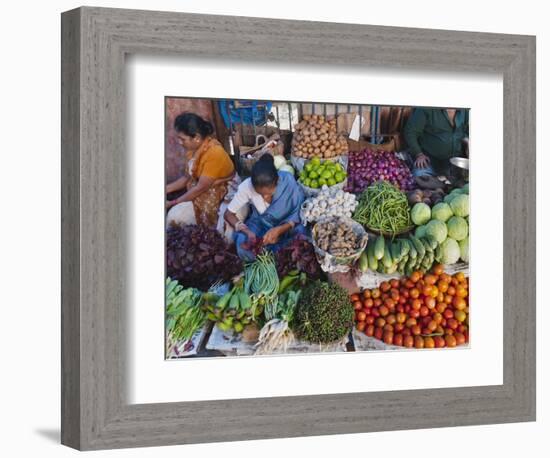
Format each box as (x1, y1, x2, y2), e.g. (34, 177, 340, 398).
(166, 225, 242, 291)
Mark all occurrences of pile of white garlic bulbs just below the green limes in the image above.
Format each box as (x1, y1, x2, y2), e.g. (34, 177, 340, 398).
(301, 188, 357, 224)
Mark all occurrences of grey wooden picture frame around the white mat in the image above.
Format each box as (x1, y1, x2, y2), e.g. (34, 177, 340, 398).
(61, 7, 536, 450)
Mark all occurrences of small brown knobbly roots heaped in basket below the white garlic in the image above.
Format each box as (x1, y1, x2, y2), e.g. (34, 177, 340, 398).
(315, 218, 364, 257)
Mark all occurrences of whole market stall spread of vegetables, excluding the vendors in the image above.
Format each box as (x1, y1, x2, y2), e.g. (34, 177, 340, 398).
(166, 104, 469, 358)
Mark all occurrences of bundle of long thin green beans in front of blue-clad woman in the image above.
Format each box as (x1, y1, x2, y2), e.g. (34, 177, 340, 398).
(244, 251, 279, 314)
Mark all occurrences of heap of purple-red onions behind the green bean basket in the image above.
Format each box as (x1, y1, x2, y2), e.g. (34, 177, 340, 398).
(346, 149, 415, 193)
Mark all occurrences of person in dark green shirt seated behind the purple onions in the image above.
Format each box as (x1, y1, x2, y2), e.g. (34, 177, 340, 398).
(403, 108, 469, 176)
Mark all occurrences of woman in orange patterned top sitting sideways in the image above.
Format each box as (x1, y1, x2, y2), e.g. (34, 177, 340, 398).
(166, 113, 235, 227)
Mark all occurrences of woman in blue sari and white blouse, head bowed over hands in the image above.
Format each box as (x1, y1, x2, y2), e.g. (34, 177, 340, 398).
(224, 154, 306, 261)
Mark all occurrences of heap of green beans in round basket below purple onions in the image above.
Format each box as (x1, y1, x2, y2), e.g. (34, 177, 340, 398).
(353, 181, 411, 235)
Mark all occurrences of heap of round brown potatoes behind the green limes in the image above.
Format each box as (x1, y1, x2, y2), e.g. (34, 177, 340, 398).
(292, 114, 348, 159)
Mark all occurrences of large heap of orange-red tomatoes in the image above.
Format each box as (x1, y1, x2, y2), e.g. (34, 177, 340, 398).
(351, 264, 469, 348)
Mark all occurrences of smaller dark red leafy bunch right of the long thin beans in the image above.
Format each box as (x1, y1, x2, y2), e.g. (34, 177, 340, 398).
(275, 234, 322, 285)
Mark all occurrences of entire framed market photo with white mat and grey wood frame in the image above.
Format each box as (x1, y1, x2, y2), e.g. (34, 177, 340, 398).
(62, 7, 536, 450)
